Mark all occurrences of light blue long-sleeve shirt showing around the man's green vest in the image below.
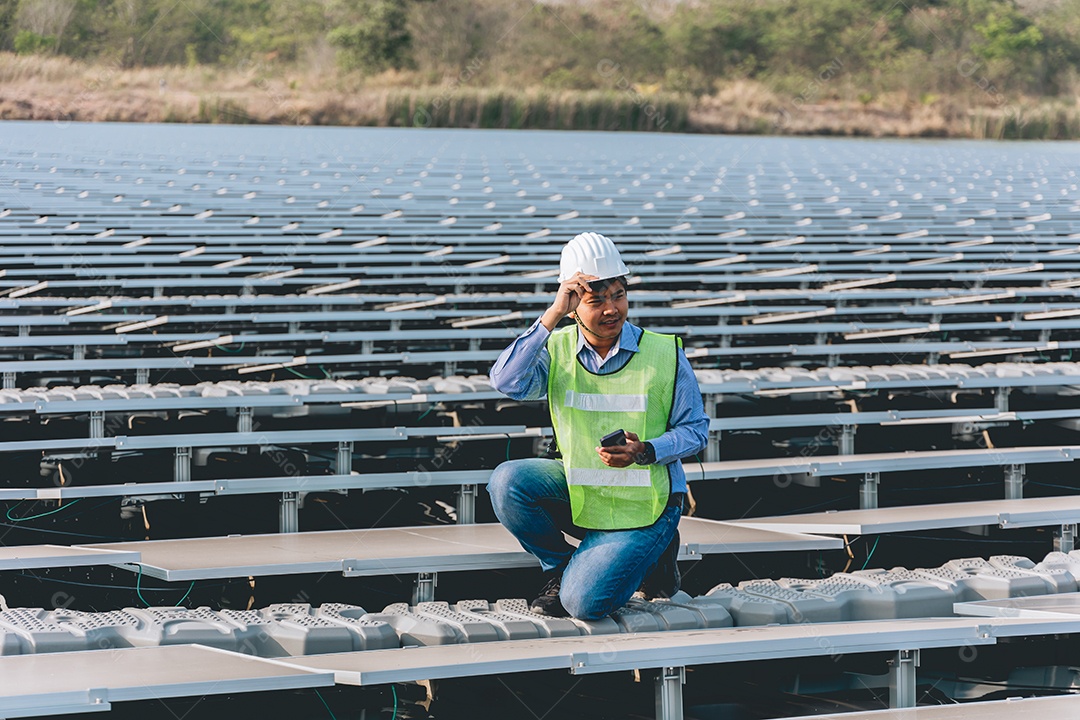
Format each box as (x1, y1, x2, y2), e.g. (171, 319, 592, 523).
(490, 320, 708, 492)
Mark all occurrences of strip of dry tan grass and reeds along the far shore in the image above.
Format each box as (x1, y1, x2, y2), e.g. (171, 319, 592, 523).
(0, 53, 1080, 139)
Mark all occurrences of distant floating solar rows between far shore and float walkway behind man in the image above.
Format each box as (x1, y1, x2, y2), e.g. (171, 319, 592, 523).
(0, 127, 1080, 385)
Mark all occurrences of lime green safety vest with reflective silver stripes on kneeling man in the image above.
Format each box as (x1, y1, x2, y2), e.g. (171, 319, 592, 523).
(548, 326, 681, 530)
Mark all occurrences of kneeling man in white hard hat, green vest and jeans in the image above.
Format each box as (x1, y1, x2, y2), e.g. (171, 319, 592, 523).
(488, 232, 708, 620)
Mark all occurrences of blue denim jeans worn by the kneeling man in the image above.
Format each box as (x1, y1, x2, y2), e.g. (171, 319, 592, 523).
(487, 458, 681, 620)
